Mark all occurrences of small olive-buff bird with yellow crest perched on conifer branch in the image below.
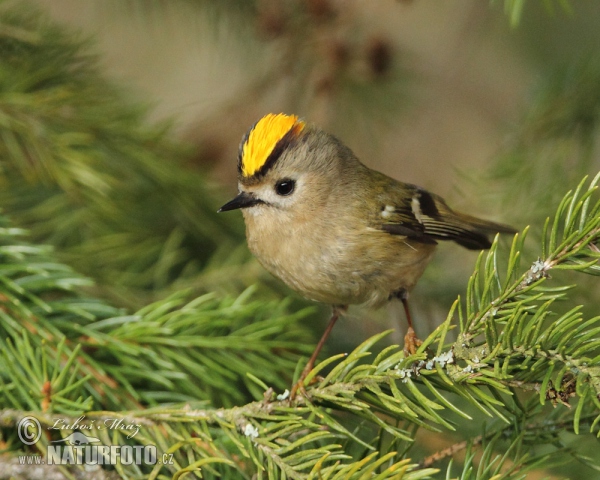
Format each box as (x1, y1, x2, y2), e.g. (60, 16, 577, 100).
(219, 113, 515, 397)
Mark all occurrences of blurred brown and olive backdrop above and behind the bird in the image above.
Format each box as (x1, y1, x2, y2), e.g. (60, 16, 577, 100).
(28, 0, 600, 344)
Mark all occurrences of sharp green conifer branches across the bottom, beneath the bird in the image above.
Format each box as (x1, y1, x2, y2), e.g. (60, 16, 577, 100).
(0, 175, 600, 479)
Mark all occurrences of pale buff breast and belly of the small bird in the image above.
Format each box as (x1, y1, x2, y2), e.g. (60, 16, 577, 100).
(244, 207, 433, 306)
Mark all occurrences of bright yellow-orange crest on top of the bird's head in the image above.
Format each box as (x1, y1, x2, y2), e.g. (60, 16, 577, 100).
(241, 113, 304, 177)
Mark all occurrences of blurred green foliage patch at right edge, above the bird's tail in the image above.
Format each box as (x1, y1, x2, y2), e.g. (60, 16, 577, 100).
(489, 60, 600, 227)
